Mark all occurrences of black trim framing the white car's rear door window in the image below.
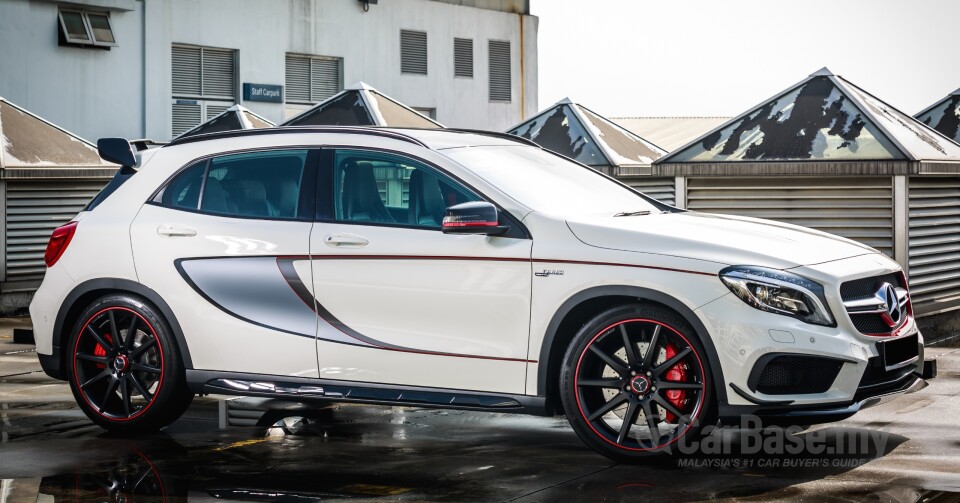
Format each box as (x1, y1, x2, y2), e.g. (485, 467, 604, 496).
(144, 145, 323, 222)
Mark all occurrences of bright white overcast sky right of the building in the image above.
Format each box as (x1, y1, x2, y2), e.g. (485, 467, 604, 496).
(530, 0, 960, 117)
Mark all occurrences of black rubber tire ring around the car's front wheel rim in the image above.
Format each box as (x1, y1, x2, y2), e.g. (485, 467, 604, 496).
(560, 304, 716, 463)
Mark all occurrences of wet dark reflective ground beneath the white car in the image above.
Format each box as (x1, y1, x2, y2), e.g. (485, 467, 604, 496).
(0, 319, 960, 503)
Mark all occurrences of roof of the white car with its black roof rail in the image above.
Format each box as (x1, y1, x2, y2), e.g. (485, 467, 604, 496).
(167, 126, 539, 150)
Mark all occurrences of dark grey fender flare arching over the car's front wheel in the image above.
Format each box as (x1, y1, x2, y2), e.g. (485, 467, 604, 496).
(537, 285, 727, 404)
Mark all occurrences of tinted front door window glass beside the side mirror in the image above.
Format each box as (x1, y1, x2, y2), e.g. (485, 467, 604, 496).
(333, 150, 480, 229)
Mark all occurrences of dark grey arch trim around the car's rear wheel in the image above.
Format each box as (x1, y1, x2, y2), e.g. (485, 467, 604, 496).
(53, 278, 193, 380)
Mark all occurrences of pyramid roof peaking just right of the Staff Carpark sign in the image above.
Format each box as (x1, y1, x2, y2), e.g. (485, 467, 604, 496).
(281, 82, 443, 128)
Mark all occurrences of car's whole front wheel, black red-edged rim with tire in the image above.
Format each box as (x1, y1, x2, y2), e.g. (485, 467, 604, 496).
(560, 304, 715, 462)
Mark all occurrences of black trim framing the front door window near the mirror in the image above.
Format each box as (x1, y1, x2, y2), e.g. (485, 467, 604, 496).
(314, 145, 533, 239)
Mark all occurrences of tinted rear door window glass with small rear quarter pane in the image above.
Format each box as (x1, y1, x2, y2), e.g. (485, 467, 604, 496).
(159, 150, 312, 219)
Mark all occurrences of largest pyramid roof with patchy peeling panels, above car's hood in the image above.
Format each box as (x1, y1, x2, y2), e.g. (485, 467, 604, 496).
(656, 68, 960, 165)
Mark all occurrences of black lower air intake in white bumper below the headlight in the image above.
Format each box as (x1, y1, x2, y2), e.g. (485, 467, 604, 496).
(748, 355, 843, 395)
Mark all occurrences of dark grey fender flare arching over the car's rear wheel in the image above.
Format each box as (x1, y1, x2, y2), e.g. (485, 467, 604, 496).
(53, 278, 193, 369)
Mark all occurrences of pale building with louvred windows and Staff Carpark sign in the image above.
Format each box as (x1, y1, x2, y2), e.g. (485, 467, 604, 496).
(0, 0, 538, 140)
